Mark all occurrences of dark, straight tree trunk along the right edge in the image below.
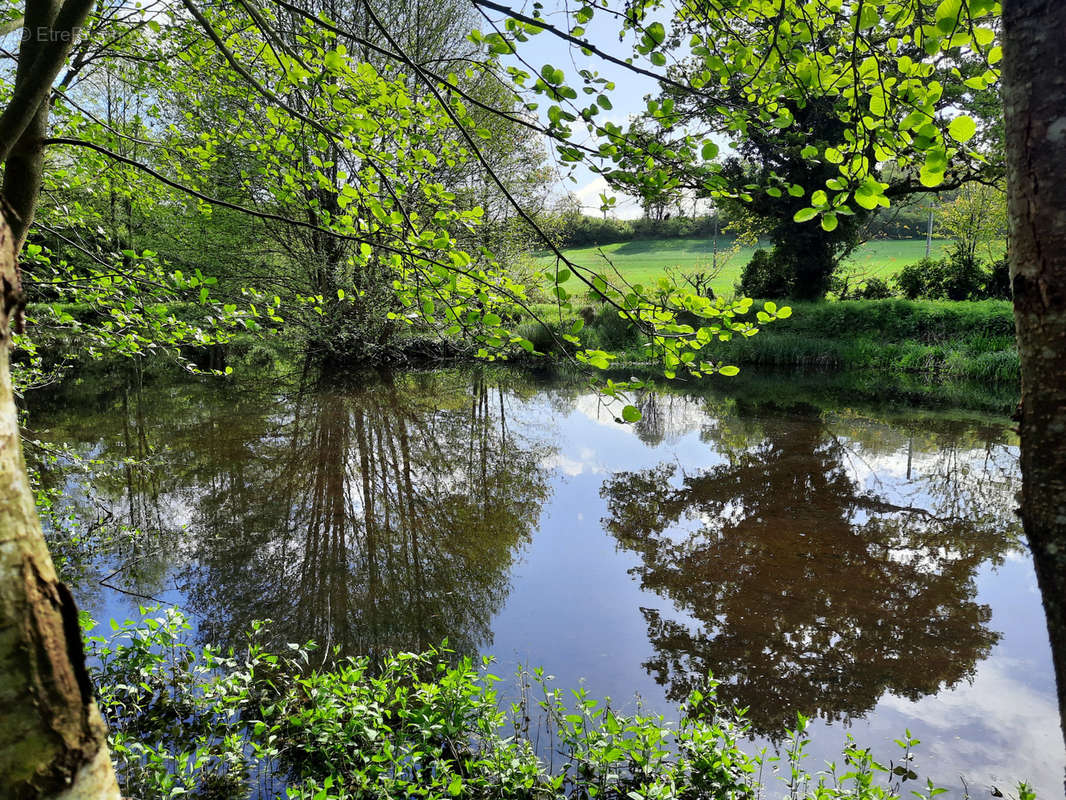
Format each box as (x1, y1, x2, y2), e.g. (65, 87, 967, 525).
(1003, 0, 1066, 785)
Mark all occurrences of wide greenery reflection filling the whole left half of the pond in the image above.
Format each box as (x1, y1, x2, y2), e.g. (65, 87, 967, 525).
(30, 370, 550, 655)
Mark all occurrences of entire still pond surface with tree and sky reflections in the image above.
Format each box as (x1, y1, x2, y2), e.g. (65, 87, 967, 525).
(28, 370, 1066, 797)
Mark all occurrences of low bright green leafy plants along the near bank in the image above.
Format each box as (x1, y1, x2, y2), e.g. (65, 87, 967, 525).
(83, 609, 1019, 800)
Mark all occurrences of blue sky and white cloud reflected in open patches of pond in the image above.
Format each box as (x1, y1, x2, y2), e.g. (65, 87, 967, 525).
(45, 377, 1066, 797)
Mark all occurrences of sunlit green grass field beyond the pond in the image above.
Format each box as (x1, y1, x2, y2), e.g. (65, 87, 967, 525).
(540, 239, 950, 294)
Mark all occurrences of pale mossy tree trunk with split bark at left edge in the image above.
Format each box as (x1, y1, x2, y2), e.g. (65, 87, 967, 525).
(0, 215, 119, 800)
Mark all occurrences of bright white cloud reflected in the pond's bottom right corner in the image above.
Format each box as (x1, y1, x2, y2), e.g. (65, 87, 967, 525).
(879, 657, 1066, 797)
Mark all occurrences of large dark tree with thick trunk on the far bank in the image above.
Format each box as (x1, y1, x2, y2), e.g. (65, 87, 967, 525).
(664, 3, 1003, 300)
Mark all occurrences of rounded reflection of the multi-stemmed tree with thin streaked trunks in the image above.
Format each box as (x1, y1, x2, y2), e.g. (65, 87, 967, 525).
(185, 379, 548, 654)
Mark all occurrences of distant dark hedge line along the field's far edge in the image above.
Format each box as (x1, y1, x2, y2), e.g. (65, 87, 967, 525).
(558, 207, 928, 247)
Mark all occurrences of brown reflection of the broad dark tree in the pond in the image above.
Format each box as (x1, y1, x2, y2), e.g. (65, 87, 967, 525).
(602, 407, 1015, 734)
